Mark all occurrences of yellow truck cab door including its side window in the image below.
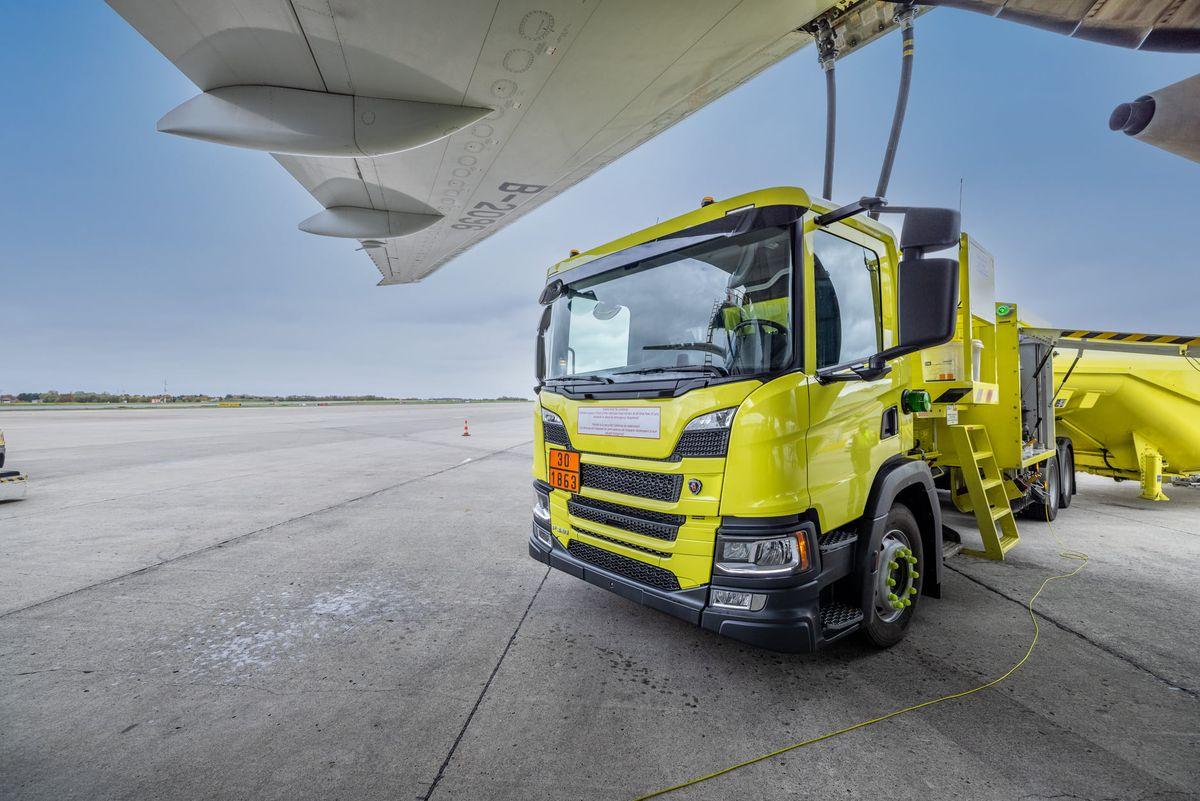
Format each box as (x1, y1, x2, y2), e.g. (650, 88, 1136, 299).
(804, 225, 905, 531)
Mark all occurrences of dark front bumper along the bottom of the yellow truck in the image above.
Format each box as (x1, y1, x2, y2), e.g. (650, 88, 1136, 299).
(529, 522, 857, 654)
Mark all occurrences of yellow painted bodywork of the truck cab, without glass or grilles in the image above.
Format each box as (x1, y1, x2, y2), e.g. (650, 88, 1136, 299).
(533, 187, 919, 589)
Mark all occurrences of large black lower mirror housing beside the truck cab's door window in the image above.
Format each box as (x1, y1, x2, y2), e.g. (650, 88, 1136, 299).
(882, 256, 959, 359)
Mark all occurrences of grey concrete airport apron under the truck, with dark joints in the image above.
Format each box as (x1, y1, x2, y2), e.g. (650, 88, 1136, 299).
(0, 403, 1200, 801)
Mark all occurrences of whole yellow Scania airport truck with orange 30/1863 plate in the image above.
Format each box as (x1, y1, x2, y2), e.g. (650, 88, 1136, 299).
(528, 187, 1195, 651)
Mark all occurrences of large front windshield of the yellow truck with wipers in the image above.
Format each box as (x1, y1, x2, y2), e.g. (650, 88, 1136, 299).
(546, 227, 793, 381)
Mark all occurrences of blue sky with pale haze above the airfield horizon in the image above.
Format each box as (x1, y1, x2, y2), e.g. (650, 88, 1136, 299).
(0, 0, 1200, 397)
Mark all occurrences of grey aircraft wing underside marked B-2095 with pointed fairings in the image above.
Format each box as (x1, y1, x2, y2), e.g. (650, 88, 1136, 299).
(108, 0, 836, 284)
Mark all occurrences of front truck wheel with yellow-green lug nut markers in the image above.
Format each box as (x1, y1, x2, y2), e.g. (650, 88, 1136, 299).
(863, 504, 925, 648)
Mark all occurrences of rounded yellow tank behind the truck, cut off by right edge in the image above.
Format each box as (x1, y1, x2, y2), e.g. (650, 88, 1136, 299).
(1055, 352, 1200, 500)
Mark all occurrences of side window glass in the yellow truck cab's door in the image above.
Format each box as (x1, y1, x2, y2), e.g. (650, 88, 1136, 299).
(812, 231, 881, 368)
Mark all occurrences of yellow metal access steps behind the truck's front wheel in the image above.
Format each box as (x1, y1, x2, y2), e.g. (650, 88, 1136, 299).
(948, 426, 1020, 560)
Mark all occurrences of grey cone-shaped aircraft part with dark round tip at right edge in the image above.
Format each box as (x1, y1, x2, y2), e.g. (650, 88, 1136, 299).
(1109, 76, 1200, 163)
